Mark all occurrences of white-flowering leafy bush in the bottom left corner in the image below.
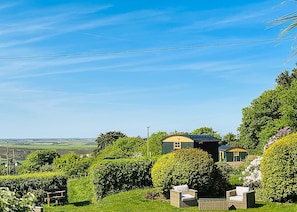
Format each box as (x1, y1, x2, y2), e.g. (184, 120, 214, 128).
(0, 187, 34, 212)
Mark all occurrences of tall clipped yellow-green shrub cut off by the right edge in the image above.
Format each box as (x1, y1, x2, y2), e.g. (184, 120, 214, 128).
(260, 133, 297, 202)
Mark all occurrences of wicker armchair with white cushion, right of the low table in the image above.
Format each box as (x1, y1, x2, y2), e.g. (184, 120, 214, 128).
(226, 186, 255, 209)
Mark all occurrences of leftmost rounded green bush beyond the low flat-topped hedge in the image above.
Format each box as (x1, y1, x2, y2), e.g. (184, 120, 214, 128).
(18, 150, 59, 174)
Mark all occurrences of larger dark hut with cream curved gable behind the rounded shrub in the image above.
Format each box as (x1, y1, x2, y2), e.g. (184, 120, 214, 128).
(162, 134, 220, 162)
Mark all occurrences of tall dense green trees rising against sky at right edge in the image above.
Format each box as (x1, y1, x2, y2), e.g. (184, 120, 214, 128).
(238, 69, 297, 153)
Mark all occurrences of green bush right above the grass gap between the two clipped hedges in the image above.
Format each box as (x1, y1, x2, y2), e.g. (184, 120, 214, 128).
(53, 152, 93, 177)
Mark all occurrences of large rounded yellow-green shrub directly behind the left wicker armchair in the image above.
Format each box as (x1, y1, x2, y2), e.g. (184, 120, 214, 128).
(152, 148, 227, 198)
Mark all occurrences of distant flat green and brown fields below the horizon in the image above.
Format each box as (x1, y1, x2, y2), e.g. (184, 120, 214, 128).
(0, 138, 97, 160)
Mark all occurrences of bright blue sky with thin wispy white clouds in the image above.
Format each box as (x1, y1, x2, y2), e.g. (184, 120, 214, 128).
(0, 0, 295, 138)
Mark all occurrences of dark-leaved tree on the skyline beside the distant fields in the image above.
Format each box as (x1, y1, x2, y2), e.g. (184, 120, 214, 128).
(95, 131, 127, 153)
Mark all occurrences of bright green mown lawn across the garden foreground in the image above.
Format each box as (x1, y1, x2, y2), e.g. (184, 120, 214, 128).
(44, 178, 297, 212)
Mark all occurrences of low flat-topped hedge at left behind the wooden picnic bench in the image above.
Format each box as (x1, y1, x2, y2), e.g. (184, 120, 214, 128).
(0, 172, 67, 202)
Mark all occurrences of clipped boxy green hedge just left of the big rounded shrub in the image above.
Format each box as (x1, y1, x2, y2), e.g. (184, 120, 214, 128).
(92, 159, 154, 199)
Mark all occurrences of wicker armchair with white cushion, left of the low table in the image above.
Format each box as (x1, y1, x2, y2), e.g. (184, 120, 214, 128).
(170, 185, 198, 208)
